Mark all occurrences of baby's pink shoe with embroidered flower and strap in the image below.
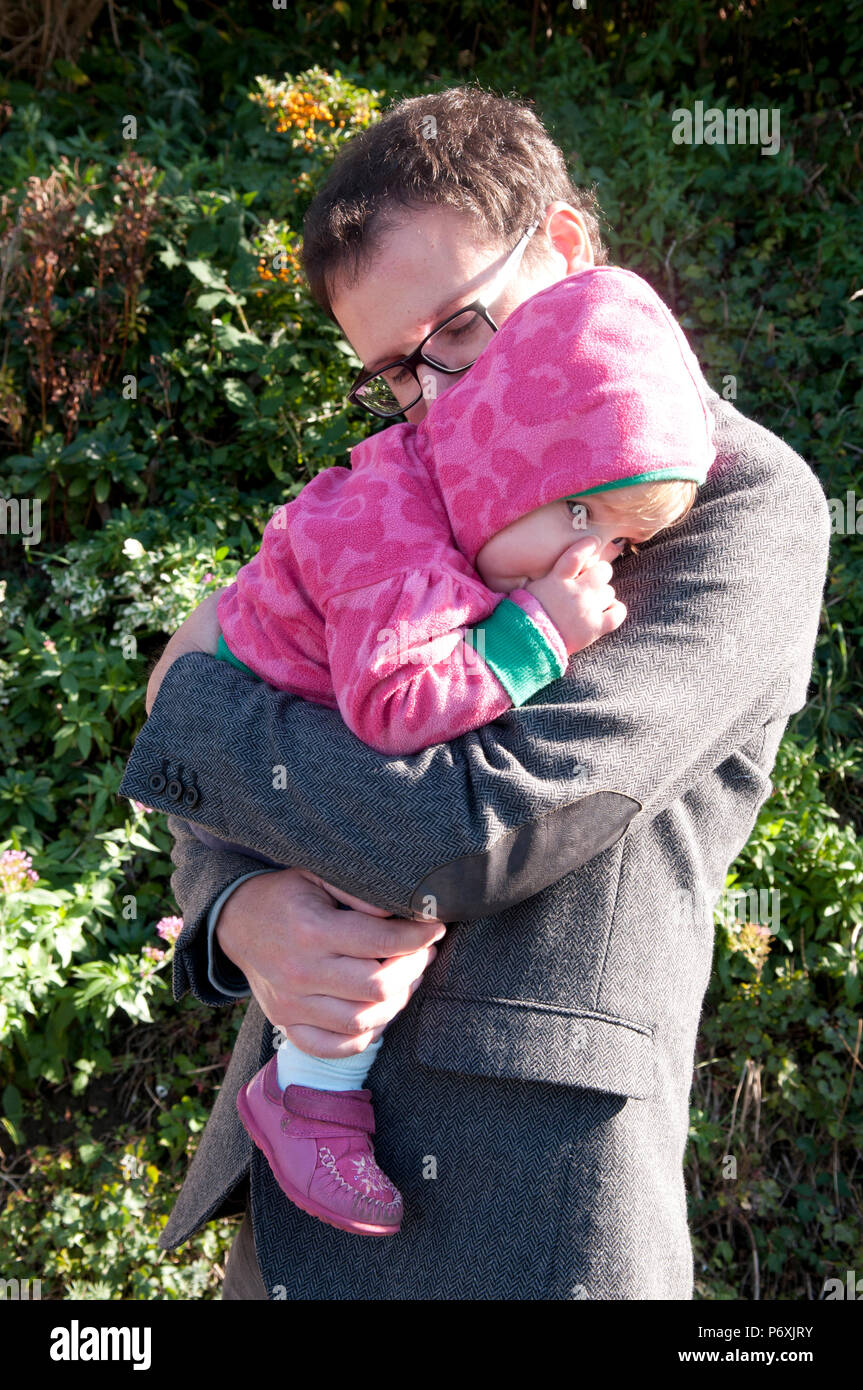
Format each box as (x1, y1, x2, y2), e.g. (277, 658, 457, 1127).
(236, 1056, 402, 1236)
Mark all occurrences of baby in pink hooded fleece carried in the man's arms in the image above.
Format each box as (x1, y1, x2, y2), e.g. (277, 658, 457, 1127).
(148, 265, 714, 1236)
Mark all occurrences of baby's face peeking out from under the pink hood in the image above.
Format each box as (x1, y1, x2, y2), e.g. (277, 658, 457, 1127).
(474, 492, 671, 594)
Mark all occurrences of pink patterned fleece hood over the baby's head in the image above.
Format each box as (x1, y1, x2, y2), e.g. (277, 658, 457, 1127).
(416, 265, 716, 564)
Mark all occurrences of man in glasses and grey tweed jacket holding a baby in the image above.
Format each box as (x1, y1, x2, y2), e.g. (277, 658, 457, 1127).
(121, 89, 830, 1300)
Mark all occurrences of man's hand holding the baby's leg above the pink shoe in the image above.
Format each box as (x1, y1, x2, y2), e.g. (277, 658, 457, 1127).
(215, 869, 446, 1056)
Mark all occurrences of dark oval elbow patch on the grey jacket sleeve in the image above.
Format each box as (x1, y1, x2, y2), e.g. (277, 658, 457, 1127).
(410, 791, 642, 922)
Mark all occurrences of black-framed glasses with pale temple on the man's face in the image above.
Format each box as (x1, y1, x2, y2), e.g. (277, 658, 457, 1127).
(346, 222, 539, 420)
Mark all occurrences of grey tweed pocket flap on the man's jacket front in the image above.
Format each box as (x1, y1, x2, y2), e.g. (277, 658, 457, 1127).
(417, 994, 656, 1101)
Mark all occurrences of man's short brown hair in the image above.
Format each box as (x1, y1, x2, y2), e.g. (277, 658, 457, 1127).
(302, 86, 607, 318)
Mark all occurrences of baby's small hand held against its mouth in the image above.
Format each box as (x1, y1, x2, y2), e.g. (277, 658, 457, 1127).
(525, 537, 627, 656)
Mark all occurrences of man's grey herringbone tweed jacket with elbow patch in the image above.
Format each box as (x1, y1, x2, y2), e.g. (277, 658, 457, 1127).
(120, 395, 830, 1300)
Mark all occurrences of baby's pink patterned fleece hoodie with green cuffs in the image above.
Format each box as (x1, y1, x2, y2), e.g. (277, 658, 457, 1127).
(218, 265, 714, 753)
